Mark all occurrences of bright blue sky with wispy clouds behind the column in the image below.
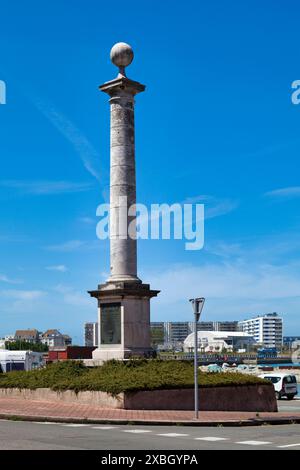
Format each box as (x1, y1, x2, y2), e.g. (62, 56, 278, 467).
(0, 0, 300, 343)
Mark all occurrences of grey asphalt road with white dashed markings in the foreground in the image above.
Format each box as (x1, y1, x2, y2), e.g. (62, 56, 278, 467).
(0, 420, 300, 451)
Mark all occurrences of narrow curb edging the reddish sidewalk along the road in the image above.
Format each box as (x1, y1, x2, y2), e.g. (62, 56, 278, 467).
(0, 413, 300, 427)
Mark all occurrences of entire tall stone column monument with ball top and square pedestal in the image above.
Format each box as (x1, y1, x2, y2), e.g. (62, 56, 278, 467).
(89, 43, 159, 361)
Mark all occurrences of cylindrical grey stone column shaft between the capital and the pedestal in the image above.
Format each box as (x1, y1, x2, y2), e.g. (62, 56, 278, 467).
(110, 92, 137, 280)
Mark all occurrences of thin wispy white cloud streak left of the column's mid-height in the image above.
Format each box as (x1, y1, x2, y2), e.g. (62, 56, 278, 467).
(0, 180, 92, 195)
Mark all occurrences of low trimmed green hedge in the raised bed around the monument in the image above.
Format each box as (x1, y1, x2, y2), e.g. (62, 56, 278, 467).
(0, 360, 273, 395)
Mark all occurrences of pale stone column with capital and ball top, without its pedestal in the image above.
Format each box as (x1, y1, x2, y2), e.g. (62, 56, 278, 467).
(100, 43, 145, 282)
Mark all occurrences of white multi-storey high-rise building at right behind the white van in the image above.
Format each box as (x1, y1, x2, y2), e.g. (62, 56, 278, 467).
(239, 313, 283, 348)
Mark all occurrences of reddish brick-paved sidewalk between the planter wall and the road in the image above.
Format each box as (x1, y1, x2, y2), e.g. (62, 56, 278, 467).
(0, 398, 300, 426)
